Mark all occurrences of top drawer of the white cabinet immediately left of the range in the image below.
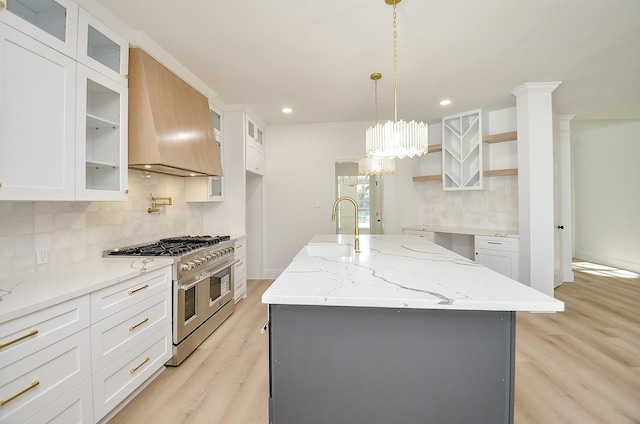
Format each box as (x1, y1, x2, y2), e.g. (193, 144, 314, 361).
(91, 267, 171, 323)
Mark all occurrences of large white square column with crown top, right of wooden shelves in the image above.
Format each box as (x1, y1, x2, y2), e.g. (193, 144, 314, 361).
(512, 82, 560, 296)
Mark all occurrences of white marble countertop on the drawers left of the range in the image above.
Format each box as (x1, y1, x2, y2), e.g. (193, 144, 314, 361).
(0, 257, 173, 323)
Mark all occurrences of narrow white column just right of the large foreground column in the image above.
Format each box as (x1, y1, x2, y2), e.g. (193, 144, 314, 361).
(558, 115, 575, 283)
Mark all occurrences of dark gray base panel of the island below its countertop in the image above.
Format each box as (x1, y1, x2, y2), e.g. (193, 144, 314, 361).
(269, 305, 515, 424)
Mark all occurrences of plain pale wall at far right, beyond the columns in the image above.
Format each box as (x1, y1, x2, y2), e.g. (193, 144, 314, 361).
(571, 120, 640, 272)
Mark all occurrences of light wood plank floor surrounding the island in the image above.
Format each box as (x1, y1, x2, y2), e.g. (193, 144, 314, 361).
(110, 264, 640, 424)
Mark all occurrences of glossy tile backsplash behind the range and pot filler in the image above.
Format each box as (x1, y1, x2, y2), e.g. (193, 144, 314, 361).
(0, 171, 203, 278)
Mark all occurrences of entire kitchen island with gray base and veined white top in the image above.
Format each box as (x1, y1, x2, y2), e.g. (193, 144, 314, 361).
(262, 235, 564, 424)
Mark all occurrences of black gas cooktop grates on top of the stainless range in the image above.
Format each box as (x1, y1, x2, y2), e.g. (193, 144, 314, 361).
(108, 236, 231, 256)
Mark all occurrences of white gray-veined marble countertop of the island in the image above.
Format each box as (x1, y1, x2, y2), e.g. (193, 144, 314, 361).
(262, 234, 564, 312)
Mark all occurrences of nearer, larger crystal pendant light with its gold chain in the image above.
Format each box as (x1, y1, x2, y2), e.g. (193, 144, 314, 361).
(366, 0, 428, 159)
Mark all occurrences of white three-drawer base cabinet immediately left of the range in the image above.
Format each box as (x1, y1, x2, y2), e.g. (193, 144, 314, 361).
(91, 267, 172, 421)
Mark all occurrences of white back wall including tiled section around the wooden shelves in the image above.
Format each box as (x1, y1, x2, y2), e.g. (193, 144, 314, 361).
(264, 108, 518, 278)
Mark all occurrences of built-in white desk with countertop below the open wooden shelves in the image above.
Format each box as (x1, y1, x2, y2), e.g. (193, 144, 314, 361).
(402, 225, 519, 280)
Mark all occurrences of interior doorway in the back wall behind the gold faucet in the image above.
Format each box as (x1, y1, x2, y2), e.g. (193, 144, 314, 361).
(335, 161, 384, 234)
